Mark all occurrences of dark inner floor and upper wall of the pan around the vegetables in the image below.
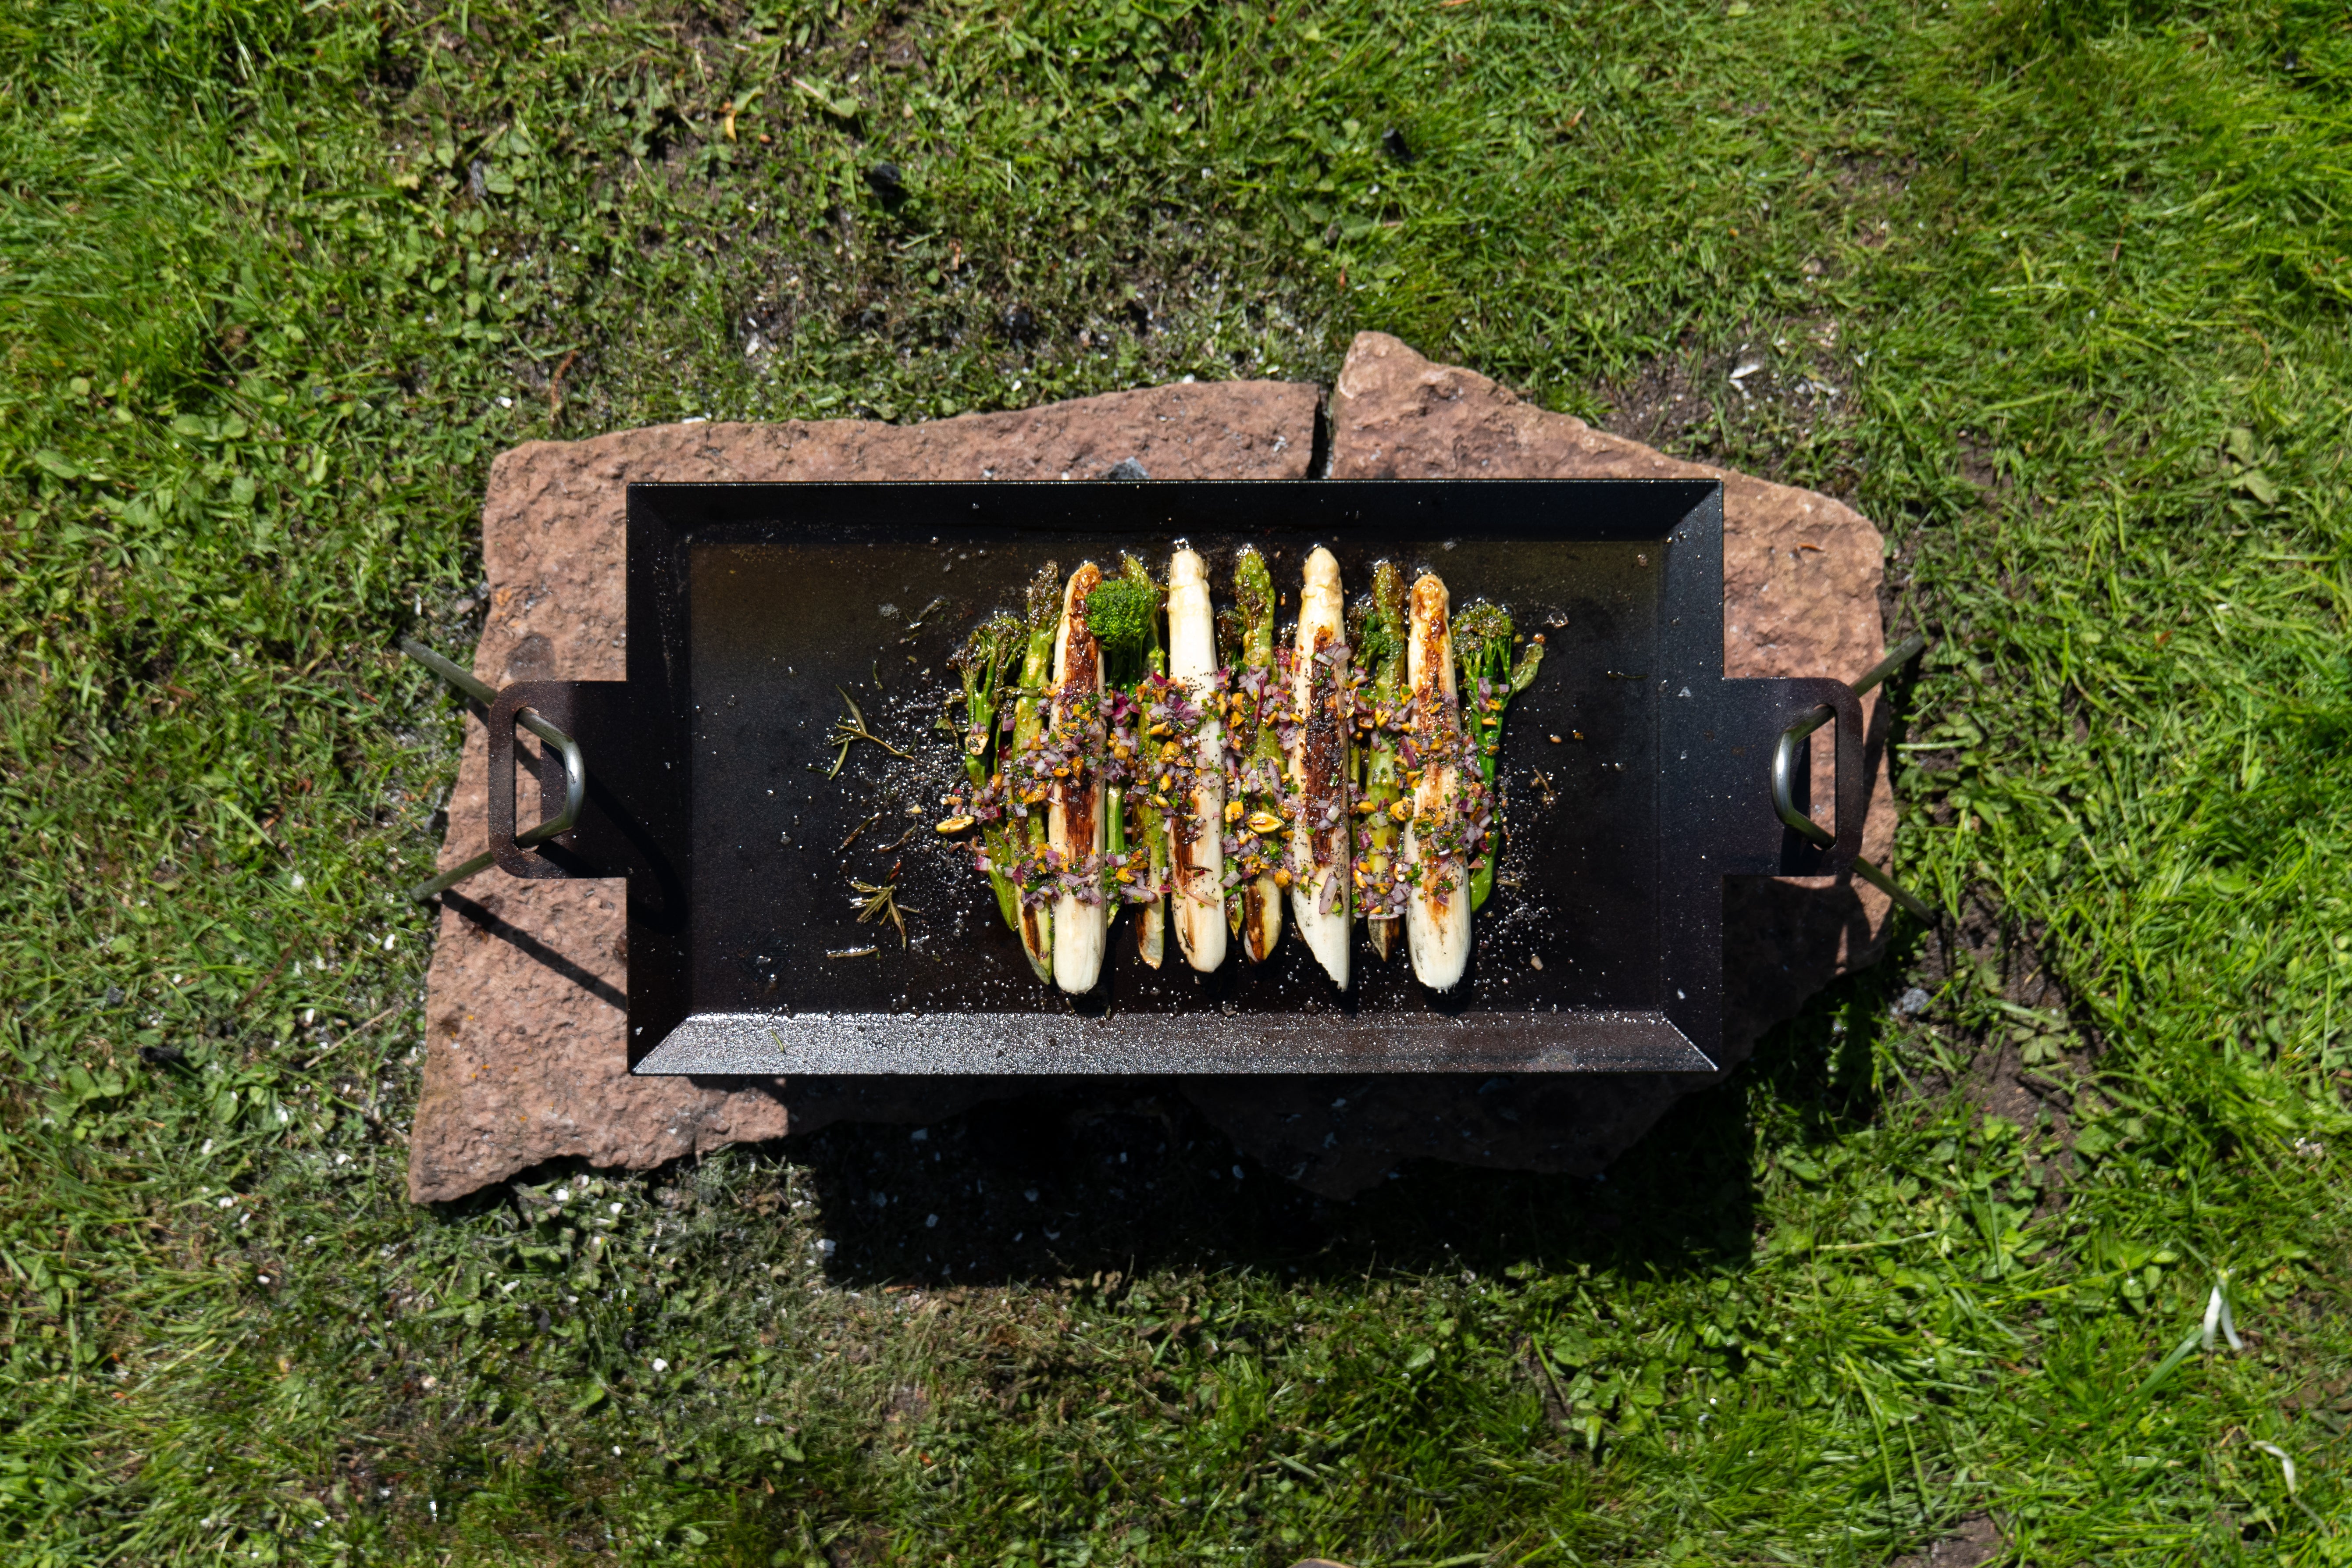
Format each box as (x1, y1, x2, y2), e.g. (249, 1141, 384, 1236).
(668, 484, 1719, 1053)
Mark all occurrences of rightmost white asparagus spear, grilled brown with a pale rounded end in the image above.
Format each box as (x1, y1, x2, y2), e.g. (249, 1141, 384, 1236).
(1404, 571, 1470, 992)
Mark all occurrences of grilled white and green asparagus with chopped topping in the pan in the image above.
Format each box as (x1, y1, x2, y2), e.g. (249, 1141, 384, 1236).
(938, 545, 1543, 994)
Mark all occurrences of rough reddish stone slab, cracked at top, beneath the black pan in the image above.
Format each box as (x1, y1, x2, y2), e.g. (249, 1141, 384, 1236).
(409, 346, 1893, 1201)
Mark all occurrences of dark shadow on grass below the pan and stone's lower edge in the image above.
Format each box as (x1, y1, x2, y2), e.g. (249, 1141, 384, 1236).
(776, 1053, 1757, 1286)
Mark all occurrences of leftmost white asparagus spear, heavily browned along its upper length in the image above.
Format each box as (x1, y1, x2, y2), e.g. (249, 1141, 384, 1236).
(1044, 562, 1110, 997)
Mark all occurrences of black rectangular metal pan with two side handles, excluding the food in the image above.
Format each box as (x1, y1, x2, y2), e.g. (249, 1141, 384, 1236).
(477, 480, 1863, 1074)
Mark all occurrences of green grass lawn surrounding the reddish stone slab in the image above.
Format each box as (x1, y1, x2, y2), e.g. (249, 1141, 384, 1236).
(0, 0, 2352, 1563)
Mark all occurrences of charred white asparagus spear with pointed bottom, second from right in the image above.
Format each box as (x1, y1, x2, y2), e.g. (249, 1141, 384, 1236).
(1291, 548, 1355, 990)
